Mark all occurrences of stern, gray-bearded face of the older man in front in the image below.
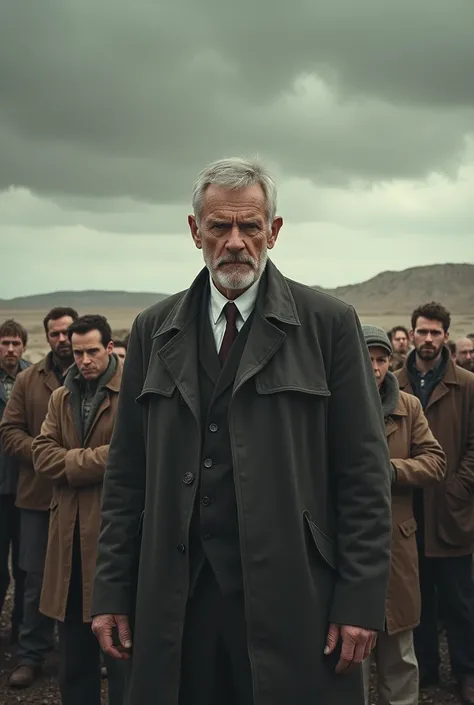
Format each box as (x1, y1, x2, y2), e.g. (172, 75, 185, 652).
(188, 185, 283, 295)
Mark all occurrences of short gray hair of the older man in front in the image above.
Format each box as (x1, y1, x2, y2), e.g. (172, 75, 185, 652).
(193, 157, 277, 224)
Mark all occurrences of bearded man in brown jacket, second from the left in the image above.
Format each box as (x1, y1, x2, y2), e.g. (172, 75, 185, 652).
(0, 307, 78, 688)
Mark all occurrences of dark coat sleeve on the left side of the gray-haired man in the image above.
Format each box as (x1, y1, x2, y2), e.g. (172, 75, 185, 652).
(92, 320, 146, 615)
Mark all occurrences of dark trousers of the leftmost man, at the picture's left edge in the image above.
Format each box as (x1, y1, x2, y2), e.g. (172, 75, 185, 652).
(0, 494, 25, 631)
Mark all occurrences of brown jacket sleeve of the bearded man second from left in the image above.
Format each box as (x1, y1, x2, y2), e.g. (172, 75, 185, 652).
(0, 374, 33, 464)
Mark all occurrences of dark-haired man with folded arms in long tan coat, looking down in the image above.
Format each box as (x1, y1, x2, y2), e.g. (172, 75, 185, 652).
(32, 315, 122, 705)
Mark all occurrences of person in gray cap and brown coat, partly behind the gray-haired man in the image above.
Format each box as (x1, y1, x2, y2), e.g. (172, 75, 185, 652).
(362, 325, 446, 705)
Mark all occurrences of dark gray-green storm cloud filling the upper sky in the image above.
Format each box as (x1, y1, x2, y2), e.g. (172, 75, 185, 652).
(0, 0, 474, 204)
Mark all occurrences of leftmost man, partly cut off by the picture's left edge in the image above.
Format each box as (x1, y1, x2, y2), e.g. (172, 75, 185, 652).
(0, 320, 30, 644)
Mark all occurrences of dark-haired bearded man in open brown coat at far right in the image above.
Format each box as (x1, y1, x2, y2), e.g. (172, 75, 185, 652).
(396, 302, 474, 705)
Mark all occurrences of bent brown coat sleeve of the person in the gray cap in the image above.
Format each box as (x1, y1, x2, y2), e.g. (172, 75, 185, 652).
(392, 396, 446, 487)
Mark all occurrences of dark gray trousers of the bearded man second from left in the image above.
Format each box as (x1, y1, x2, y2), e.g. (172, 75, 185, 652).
(18, 509, 54, 666)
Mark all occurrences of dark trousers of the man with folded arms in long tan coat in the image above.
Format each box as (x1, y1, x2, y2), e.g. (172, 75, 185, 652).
(58, 533, 123, 705)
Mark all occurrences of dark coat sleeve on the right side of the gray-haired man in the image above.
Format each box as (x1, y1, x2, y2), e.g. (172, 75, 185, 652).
(328, 307, 392, 630)
